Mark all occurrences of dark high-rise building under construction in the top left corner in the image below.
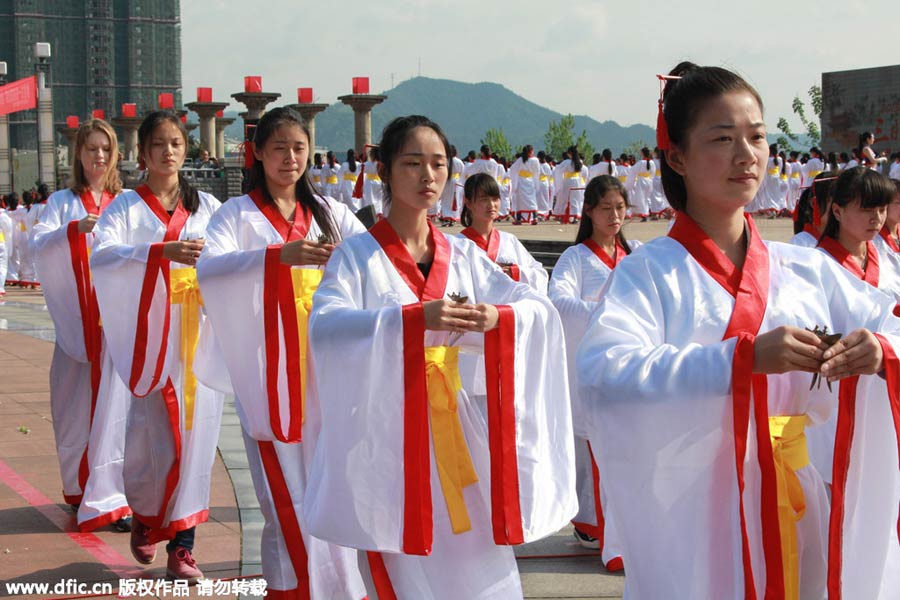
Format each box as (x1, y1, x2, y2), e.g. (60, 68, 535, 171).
(0, 0, 181, 149)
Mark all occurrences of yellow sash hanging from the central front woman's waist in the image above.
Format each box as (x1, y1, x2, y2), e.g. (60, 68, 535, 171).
(425, 346, 478, 533)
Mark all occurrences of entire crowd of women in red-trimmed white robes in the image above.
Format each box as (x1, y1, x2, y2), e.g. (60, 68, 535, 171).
(0, 63, 900, 599)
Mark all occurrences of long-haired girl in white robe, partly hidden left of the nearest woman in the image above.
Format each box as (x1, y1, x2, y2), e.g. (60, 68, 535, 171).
(549, 175, 641, 571)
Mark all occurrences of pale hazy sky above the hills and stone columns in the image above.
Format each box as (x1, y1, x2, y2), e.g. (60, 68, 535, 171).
(181, 0, 888, 131)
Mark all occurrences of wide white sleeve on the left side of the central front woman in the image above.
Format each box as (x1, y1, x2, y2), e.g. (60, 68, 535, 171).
(303, 242, 412, 552)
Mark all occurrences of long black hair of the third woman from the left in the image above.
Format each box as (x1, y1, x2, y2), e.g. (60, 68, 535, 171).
(247, 106, 341, 244)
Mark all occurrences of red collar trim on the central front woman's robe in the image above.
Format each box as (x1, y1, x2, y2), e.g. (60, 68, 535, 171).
(369, 219, 450, 302)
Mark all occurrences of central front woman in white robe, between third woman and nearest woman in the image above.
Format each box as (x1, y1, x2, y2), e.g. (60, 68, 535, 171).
(304, 116, 575, 600)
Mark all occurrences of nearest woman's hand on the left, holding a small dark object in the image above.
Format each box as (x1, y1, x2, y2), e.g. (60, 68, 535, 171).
(753, 325, 828, 373)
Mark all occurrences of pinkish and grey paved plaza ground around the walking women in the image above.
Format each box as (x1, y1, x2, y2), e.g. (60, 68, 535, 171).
(0, 219, 792, 600)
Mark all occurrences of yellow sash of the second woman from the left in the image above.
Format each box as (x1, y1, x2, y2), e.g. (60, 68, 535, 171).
(169, 267, 203, 431)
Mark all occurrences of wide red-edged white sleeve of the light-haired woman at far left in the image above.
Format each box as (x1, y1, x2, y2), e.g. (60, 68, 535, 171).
(31, 196, 90, 362)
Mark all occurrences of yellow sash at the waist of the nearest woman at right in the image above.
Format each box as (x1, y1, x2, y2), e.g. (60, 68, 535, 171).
(769, 415, 809, 600)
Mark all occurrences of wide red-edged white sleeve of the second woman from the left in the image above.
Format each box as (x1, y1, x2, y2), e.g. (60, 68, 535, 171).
(90, 200, 171, 396)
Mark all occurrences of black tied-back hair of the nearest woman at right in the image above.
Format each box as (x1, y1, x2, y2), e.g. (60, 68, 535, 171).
(659, 62, 763, 211)
